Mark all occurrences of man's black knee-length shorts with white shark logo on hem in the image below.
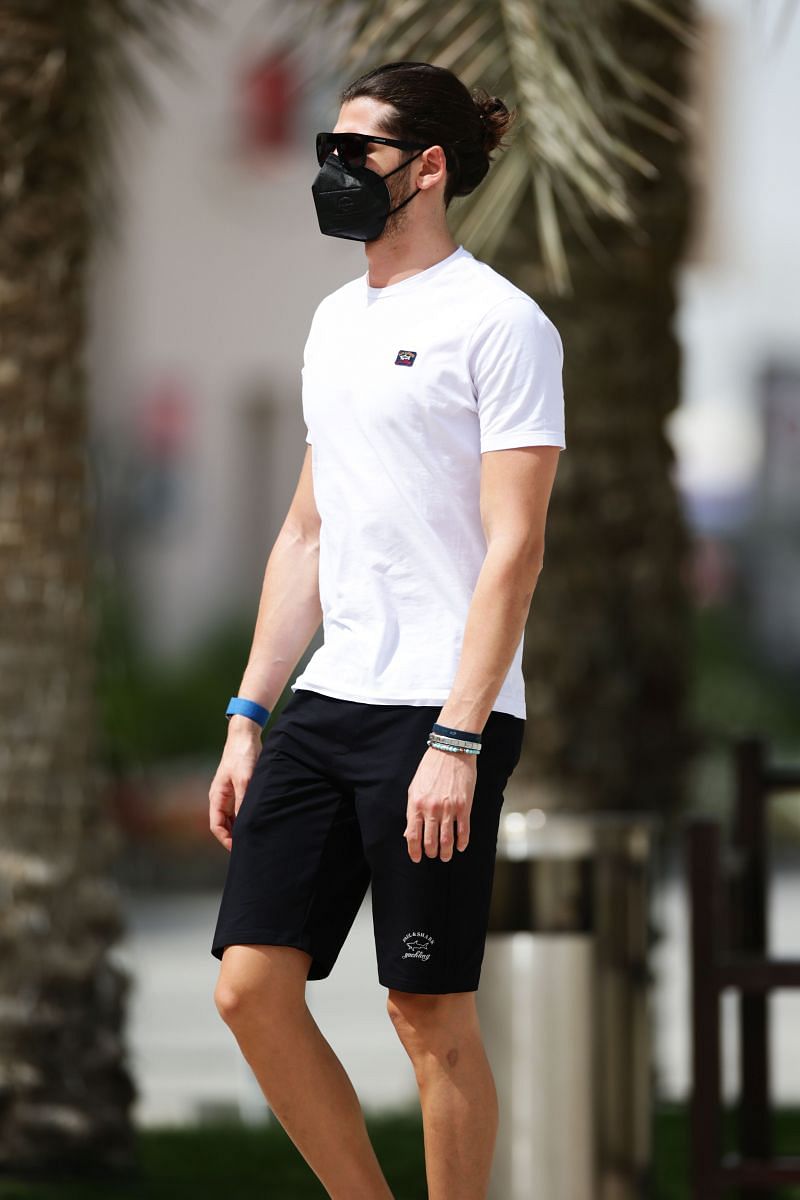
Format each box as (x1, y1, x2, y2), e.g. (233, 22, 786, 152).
(211, 688, 525, 994)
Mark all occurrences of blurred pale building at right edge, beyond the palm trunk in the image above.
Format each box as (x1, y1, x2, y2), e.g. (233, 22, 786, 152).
(670, 0, 800, 672)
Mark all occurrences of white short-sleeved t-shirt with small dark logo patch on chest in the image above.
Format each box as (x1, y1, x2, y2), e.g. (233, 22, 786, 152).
(291, 238, 566, 718)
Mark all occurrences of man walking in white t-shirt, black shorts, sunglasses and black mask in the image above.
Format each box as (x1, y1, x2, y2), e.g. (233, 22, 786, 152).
(209, 62, 566, 1200)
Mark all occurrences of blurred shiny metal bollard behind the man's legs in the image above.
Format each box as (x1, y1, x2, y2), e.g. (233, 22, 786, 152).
(477, 809, 657, 1200)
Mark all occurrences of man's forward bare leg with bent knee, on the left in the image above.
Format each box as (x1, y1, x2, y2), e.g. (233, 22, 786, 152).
(213, 946, 392, 1200)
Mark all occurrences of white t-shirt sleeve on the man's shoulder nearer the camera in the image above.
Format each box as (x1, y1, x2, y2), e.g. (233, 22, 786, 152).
(469, 296, 566, 452)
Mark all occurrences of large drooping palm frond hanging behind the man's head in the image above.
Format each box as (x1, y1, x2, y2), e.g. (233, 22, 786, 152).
(286, 0, 698, 293)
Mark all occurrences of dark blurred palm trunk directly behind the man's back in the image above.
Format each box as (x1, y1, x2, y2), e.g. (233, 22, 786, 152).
(513, 2, 692, 812)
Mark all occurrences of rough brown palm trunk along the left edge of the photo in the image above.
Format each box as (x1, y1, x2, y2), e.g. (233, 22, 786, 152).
(0, 0, 134, 1171)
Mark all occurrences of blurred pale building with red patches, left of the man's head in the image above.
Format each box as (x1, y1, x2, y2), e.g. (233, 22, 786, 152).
(90, 0, 367, 666)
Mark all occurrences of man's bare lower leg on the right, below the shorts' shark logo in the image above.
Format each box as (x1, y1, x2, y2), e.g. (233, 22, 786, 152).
(386, 988, 499, 1200)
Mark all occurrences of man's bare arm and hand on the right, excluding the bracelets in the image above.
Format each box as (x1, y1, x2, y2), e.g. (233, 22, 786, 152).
(405, 445, 560, 862)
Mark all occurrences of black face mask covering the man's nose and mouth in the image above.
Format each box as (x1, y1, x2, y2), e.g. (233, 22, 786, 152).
(311, 150, 423, 241)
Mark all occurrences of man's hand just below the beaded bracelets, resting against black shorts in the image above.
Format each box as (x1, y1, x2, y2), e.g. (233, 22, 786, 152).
(403, 746, 477, 863)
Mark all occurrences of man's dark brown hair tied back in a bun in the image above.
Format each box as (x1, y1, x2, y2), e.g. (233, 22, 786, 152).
(339, 62, 517, 208)
